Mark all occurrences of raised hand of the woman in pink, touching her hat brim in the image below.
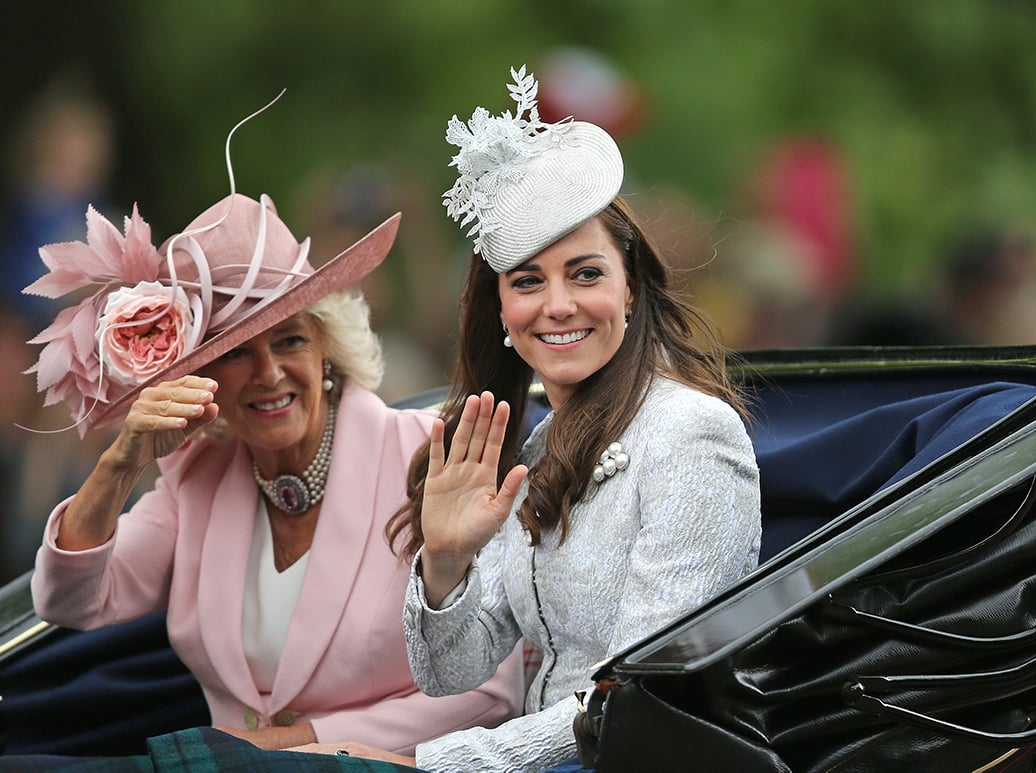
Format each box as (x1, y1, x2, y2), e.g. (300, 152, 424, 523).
(111, 376, 219, 469)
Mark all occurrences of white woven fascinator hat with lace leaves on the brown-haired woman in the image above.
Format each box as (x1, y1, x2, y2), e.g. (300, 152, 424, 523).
(442, 65, 623, 274)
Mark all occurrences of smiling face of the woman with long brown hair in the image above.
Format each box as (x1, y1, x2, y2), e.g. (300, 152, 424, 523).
(498, 219, 633, 409)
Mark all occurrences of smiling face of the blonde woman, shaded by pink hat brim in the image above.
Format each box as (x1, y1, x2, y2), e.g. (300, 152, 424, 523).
(201, 313, 326, 478)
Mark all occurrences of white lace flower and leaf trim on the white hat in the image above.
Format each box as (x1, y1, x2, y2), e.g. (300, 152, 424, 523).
(442, 64, 571, 257)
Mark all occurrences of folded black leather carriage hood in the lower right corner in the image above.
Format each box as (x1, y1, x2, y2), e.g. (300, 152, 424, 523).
(575, 368, 1036, 773)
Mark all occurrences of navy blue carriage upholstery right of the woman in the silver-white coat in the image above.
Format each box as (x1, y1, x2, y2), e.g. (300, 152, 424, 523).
(751, 374, 1036, 563)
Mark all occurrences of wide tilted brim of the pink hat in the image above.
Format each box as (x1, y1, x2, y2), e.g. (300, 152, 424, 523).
(85, 212, 402, 429)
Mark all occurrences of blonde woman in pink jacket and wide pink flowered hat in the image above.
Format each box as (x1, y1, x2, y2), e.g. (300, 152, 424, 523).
(28, 183, 521, 754)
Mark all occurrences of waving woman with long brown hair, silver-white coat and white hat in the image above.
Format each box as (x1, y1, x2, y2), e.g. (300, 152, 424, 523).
(292, 67, 760, 772)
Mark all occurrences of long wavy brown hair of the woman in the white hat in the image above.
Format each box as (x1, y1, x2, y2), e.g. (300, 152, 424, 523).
(385, 192, 745, 555)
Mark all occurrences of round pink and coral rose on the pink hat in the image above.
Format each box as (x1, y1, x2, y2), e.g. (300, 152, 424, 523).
(96, 282, 201, 385)
